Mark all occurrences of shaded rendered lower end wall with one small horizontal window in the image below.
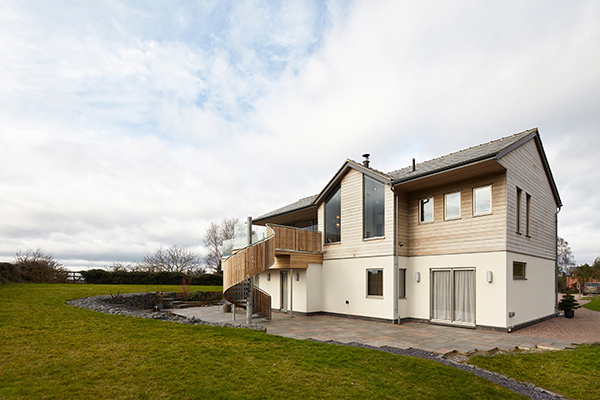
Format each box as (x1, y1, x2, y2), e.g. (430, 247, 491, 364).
(506, 253, 555, 327)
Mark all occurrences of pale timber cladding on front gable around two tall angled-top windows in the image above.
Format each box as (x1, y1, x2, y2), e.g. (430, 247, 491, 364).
(318, 169, 394, 259)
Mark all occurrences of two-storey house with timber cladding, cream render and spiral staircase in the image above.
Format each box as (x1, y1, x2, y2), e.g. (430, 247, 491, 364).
(223, 129, 562, 331)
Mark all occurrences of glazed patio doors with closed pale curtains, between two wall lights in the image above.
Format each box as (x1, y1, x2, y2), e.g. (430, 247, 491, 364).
(431, 269, 475, 325)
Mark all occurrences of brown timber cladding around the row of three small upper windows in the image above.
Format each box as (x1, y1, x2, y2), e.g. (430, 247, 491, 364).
(408, 173, 506, 256)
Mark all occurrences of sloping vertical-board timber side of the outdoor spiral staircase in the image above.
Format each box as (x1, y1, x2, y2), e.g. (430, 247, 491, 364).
(223, 228, 275, 290)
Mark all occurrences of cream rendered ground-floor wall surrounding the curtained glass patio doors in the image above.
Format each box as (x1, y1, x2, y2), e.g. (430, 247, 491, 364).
(406, 252, 512, 328)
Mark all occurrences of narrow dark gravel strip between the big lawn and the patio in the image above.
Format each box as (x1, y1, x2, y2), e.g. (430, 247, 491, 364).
(314, 340, 564, 400)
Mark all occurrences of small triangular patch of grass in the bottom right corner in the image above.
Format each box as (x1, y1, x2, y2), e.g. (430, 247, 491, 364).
(469, 344, 600, 399)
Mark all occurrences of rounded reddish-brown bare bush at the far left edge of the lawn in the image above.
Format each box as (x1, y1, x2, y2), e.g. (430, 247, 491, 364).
(15, 249, 67, 282)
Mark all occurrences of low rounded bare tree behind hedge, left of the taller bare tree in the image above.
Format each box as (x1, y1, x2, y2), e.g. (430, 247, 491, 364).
(140, 245, 204, 273)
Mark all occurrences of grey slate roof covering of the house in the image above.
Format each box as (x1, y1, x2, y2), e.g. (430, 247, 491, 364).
(256, 128, 548, 220)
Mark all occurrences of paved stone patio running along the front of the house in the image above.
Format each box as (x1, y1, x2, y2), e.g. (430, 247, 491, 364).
(169, 307, 573, 354)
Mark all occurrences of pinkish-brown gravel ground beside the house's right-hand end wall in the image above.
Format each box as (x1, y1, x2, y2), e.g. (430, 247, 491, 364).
(515, 295, 600, 344)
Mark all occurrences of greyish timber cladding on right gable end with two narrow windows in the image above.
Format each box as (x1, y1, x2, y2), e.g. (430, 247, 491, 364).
(499, 140, 557, 260)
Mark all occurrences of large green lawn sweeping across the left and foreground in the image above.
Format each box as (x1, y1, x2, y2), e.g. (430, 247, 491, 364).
(0, 284, 523, 399)
